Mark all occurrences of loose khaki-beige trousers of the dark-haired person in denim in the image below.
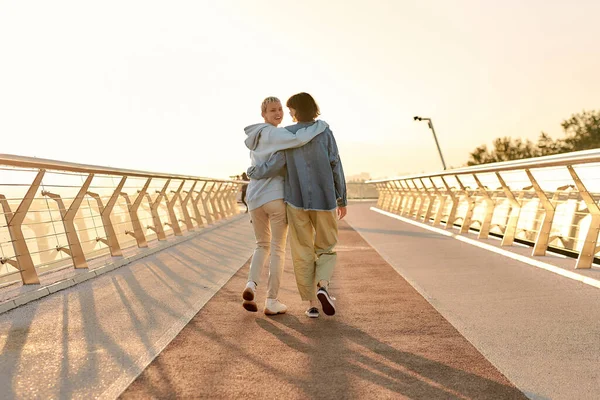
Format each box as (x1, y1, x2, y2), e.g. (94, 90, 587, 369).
(287, 205, 338, 301)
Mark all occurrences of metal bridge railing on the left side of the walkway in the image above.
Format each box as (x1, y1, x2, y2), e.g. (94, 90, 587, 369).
(0, 154, 243, 284)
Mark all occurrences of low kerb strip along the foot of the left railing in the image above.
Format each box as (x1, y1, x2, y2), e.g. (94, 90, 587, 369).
(0, 213, 246, 314)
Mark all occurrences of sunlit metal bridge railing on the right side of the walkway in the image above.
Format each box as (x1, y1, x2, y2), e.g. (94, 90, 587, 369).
(369, 149, 600, 268)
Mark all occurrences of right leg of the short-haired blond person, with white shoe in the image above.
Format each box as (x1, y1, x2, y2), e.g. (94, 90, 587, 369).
(264, 200, 288, 315)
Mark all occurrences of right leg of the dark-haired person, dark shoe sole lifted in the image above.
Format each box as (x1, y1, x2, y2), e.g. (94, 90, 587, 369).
(311, 211, 338, 315)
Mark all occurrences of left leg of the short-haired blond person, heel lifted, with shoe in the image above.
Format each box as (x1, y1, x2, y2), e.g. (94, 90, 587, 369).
(242, 206, 271, 311)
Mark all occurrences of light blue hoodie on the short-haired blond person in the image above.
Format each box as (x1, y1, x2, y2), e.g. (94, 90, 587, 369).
(244, 121, 328, 211)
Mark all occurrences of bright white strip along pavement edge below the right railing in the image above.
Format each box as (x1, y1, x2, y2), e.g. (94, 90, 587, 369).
(370, 207, 600, 289)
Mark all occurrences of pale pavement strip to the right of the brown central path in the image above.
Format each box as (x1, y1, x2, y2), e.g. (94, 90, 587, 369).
(347, 203, 600, 399)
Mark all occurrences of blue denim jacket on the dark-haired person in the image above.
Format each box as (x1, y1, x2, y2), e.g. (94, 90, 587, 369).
(248, 122, 348, 211)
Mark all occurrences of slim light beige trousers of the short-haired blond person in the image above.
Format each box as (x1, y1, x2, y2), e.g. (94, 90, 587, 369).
(248, 199, 287, 299)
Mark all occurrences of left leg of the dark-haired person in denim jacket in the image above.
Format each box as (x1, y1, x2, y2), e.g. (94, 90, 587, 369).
(287, 205, 317, 316)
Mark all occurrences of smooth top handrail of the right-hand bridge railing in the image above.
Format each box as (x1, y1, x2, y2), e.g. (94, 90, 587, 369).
(367, 149, 600, 183)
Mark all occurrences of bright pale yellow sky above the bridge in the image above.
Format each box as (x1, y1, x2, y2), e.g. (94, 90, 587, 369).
(0, 0, 600, 178)
